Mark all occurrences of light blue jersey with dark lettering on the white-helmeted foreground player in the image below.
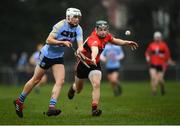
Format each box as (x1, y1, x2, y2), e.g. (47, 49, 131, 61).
(41, 19, 83, 59)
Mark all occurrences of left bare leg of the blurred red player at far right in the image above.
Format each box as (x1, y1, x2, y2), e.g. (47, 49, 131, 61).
(149, 68, 158, 95)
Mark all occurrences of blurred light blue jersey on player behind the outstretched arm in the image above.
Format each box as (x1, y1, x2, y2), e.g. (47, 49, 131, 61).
(101, 44, 124, 69)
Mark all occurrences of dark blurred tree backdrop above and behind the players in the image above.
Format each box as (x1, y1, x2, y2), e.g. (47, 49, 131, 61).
(0, 0, 180, 82)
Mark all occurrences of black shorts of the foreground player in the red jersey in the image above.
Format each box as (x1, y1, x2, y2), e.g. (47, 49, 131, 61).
(75, 61, 101, 79)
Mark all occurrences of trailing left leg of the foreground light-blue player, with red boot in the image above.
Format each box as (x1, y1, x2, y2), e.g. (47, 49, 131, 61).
(14, 66, 45, 117)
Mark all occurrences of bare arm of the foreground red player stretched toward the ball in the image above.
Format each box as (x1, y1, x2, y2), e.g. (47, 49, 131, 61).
(110, 38, 138, 50)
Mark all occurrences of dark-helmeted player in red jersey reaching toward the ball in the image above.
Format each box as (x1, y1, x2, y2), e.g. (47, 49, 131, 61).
(68, 20, 138, 116)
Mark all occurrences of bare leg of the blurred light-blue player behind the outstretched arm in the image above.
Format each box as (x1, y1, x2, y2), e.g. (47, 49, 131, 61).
(108, 71, 122, 96)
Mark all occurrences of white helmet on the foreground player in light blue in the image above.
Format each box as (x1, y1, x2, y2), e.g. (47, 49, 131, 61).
(66, 8, 82, 20)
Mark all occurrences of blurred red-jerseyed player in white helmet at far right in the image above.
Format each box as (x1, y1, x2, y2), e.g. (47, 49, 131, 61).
(145, 31, 175, 95)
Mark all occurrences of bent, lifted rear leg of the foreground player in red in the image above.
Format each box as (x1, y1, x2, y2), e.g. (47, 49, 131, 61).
(68, 76, 84, 99)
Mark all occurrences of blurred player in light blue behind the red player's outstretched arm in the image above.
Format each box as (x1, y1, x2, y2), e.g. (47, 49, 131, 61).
(100, 44, 124, 96)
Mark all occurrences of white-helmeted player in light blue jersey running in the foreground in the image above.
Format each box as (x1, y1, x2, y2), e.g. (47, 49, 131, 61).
(14, 8, 83, 118)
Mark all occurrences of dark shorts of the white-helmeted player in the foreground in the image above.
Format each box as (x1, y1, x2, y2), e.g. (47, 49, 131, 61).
(38, 53, 64, 70)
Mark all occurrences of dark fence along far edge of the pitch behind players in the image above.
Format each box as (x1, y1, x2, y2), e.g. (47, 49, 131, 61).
(0, 64, 180, 85)
